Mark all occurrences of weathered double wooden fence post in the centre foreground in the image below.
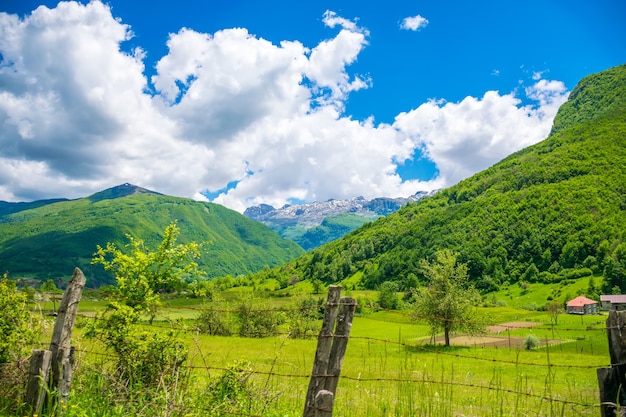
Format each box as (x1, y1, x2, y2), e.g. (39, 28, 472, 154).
(303, 285, 356, 417)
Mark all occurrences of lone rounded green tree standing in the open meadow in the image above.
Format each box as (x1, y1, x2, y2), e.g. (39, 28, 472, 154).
(415, 249, 484, 346)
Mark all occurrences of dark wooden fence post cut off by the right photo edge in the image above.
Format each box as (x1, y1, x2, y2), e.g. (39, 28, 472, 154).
(597, 310, 626, 417)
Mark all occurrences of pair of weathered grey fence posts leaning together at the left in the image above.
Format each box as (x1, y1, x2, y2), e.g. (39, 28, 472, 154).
(25, 268, 86, 414)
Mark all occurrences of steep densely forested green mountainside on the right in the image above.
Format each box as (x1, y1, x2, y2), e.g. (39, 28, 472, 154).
(264, 66, 626, 290)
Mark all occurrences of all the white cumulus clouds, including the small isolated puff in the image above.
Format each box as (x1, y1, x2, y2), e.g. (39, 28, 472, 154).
(0, 2, 566, 211)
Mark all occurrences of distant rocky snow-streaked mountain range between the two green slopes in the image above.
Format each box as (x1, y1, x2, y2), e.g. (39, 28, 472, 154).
(243, 191, 435, 250)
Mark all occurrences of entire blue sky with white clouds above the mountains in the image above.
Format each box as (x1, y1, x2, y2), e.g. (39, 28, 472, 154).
(0, 0, 626, 212)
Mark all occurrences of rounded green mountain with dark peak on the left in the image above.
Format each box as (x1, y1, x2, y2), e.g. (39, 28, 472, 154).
(0, 184, 304, 286)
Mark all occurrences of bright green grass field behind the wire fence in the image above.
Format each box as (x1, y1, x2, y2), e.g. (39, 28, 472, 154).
(35, 283, 610, 416)
